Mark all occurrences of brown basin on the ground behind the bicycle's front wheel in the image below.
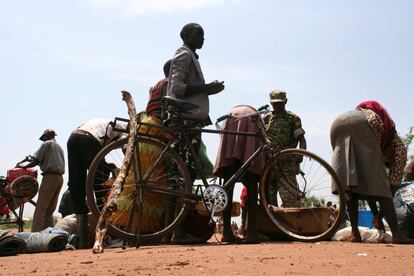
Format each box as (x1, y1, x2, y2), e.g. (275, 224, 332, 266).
(257, 204, 330, 240)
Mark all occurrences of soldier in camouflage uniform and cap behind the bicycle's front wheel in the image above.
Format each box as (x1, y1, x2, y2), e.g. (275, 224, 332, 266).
(265, 90, 306, 207)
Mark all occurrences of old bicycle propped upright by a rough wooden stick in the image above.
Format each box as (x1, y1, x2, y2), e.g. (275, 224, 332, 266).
(86, 91, 345, 253)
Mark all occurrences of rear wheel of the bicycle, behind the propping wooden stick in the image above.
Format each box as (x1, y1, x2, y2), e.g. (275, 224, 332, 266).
(86, 137, 191, 242)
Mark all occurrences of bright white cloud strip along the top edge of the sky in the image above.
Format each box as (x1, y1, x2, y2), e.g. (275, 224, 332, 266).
(88, 0, 233, 15)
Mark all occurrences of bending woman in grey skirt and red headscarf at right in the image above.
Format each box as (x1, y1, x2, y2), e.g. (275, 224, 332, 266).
(331, 101, 411, 243)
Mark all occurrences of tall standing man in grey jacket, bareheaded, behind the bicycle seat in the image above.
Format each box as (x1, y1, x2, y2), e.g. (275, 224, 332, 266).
(167, 23, 224, 244)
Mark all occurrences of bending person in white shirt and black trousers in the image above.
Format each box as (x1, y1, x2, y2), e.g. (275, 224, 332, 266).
(67, 119, 123, 248)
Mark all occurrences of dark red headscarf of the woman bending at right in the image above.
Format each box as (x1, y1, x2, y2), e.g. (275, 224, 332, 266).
(356, 101, 395, 151)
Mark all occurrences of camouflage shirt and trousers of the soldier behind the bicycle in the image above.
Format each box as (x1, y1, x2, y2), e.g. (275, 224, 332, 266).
(265, 104, 305, 207)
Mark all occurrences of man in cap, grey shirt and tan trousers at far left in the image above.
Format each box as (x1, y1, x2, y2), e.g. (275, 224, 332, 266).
(16, 129, 65, 232)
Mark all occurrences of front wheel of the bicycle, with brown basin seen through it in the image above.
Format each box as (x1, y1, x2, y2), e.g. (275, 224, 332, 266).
(259, 149, 345, 241)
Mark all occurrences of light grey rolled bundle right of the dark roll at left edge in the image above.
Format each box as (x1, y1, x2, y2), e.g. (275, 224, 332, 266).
(16, 232, 68, 253)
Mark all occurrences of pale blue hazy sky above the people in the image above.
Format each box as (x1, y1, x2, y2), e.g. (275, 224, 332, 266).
(0, 0, 414, 218)
